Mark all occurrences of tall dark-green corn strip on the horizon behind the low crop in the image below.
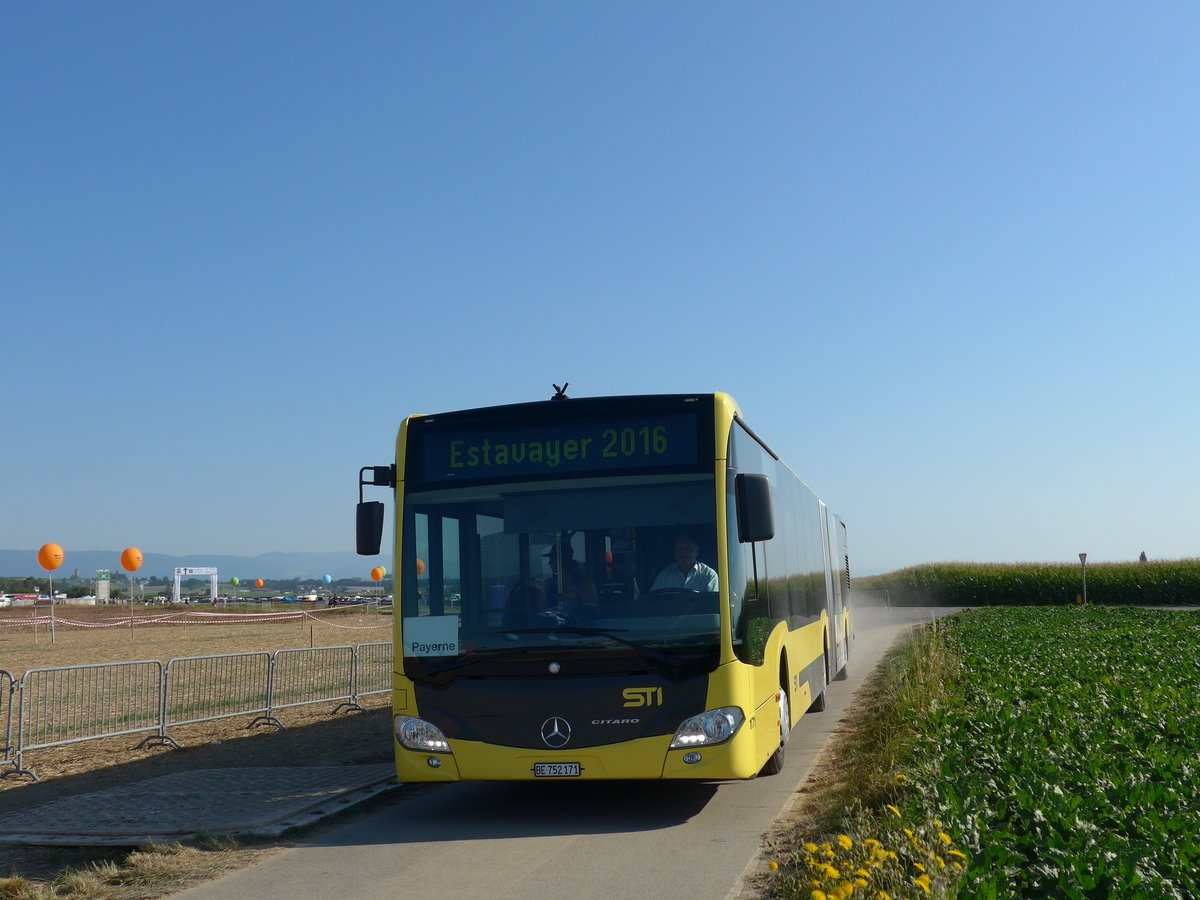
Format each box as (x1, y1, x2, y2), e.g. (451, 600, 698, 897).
(853, 559, 1200, 606)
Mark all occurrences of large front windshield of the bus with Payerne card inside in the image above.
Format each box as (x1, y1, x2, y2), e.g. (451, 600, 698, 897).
(400, 474, 720, 679)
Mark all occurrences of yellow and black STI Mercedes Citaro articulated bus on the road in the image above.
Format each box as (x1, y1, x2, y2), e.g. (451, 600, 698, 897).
(358, 391, 852, 781)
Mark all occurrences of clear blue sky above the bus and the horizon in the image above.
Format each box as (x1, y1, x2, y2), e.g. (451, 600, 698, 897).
(0, 0, 1200, 574)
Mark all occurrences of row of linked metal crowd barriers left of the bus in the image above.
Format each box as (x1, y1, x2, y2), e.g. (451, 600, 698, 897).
(0, 643, 392, 781)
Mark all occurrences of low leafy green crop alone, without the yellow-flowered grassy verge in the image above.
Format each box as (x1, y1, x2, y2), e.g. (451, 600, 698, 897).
(906, 607, 1200, 898)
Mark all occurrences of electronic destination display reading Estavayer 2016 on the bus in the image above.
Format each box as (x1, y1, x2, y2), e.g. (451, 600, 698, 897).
(410, 413, 698, 482)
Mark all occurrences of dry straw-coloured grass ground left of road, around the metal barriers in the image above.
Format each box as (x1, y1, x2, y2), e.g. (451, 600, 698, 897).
(0, 606, 405, 900)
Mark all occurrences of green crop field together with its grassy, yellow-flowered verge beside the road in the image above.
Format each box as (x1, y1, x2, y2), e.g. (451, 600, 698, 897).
(775, 606, 1200, 900)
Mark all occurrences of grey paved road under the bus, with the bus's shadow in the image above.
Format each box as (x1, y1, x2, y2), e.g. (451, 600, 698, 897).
(178, 608, 948, 900)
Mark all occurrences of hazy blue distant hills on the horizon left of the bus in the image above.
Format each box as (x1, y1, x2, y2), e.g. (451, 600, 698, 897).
(0, 550, 381, 581)
